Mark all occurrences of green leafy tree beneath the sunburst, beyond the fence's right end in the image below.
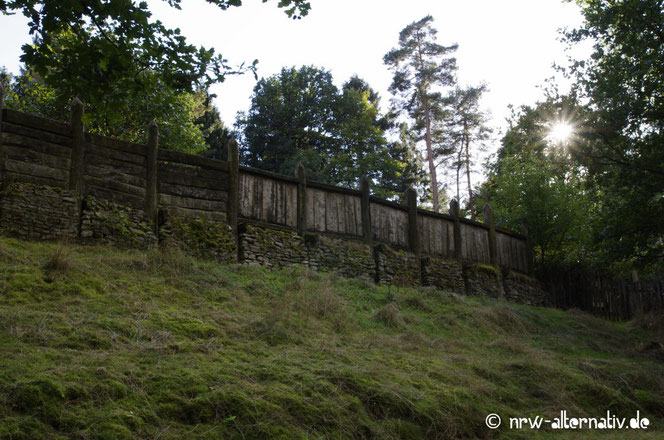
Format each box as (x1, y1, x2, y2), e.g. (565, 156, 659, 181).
(478, 97, 595, 267)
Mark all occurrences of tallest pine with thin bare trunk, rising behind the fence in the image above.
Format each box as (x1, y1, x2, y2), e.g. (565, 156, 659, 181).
(383, 15, 458, 212)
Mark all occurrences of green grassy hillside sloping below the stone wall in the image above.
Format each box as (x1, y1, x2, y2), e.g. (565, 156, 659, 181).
(0, 238, 664, 439)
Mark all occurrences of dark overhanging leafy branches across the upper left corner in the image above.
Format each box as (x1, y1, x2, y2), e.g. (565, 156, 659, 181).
(0, 0, 309, 117)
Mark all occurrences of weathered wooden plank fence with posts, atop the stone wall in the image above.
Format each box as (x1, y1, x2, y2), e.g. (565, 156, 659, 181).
(0, 100, 532, 273)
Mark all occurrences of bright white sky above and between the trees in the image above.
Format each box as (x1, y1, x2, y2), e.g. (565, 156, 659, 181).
(0, 0, 589, 184)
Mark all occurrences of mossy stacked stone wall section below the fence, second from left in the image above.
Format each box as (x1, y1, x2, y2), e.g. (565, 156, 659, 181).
(81, 196, 157, 249)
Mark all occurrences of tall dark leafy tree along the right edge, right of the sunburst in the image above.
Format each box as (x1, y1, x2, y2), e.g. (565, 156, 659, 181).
(566, 0, 664, 266)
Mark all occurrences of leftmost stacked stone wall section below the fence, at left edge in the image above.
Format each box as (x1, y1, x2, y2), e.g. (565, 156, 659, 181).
(0, 183, 79, 241)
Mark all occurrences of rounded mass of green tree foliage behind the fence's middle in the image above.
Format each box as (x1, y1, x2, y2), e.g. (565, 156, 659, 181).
(237, 66, 406, 196)
